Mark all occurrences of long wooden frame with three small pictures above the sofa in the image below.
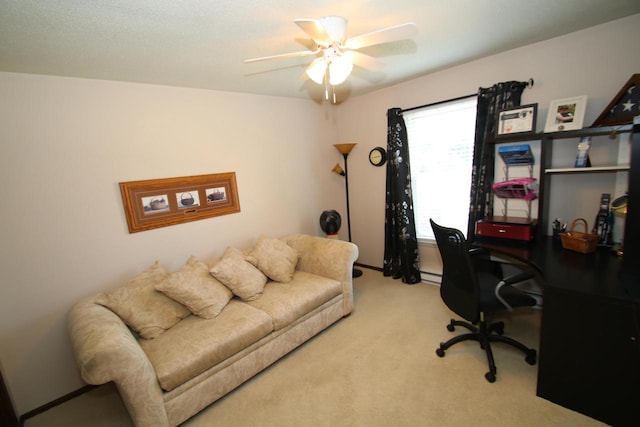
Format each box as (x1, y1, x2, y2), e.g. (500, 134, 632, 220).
(120, 172, 240, 233)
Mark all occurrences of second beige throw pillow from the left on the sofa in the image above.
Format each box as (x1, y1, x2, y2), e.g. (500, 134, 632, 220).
(156, 256, 233, 319)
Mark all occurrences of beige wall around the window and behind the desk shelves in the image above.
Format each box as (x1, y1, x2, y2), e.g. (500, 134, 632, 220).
(339, 15, 640, 270)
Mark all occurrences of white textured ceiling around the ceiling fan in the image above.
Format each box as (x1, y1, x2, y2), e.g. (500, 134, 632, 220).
(0, 0, 640, 100)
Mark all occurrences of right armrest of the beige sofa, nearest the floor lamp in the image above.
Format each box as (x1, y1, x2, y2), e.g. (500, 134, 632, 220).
(283, 234, 359, 316)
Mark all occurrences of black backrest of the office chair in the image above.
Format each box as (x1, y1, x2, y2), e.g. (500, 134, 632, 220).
(429, 219, 480, 323)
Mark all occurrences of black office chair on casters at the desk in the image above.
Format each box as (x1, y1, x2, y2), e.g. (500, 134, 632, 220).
(430, 220, 536, 383)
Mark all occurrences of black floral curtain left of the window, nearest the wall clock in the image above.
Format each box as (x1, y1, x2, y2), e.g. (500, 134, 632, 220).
(383, 108, 420, 284)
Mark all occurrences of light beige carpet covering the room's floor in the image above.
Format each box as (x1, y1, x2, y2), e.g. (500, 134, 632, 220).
(24, 269, 603, 427)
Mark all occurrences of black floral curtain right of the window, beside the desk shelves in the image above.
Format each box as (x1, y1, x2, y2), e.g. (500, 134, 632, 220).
(467, 81, 528, 240)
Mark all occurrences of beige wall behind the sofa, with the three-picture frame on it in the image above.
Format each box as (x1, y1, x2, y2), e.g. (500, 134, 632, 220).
(0, 73, 344, 413)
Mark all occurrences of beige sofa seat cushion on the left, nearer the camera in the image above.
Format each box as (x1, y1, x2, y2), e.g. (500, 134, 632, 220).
(140, 300, 273, 391)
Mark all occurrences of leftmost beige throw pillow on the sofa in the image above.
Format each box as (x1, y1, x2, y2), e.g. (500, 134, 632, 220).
(96, 261, 190, 339)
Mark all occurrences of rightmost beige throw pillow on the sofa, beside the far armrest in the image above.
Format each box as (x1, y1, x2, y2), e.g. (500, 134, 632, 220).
(247, 236, 300, 283)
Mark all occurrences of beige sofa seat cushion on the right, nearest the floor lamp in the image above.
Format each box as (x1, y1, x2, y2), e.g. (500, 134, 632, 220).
(248, 271, 342, 330)
